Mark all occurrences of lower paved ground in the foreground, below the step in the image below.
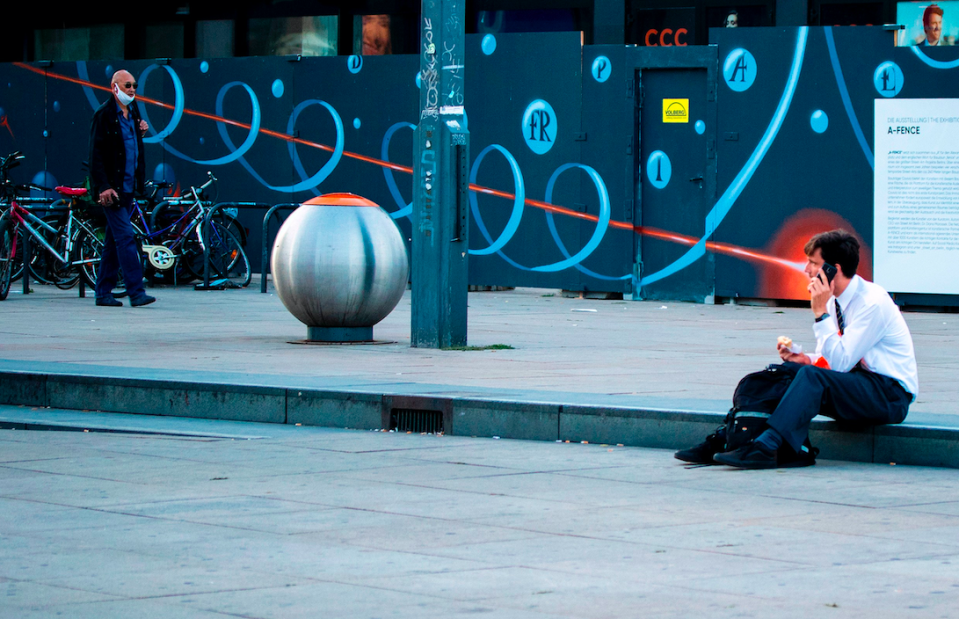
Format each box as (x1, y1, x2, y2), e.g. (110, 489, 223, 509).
(0, 406, 959, 619)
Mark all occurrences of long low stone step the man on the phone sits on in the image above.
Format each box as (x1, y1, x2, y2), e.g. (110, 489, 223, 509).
(0, 364, 959, 468)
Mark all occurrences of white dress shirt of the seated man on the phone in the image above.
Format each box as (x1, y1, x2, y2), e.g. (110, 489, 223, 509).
(810, 275, 919, 400)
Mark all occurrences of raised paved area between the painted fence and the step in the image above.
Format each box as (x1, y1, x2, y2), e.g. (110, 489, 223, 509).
(0, 281, 959, 424)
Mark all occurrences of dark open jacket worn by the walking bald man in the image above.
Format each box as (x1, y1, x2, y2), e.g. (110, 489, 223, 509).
(90, 96, 146, 200)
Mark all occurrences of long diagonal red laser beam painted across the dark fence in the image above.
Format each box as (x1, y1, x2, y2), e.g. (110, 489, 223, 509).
(8, 62, 801, 269)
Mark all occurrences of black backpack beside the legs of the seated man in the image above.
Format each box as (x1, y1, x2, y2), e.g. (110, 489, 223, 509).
(725, 362, 819, 463)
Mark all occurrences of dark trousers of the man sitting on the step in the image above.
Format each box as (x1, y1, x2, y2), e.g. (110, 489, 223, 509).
(769, 365, 912, 452)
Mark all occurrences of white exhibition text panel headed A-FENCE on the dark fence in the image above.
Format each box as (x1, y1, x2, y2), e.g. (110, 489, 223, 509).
(873, 99, 959, 294)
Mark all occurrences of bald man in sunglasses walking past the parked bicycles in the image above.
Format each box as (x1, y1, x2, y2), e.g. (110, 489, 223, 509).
(90, 70, 156, 307)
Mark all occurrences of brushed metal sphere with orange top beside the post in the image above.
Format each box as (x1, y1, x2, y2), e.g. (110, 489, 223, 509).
(270, 193, 409, 342)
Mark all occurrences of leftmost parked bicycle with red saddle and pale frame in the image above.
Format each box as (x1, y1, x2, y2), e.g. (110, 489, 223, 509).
(0, 152, 102, 301)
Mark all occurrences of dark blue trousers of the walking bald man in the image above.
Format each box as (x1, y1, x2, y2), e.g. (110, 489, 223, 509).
(95, 194, 145, 299)
